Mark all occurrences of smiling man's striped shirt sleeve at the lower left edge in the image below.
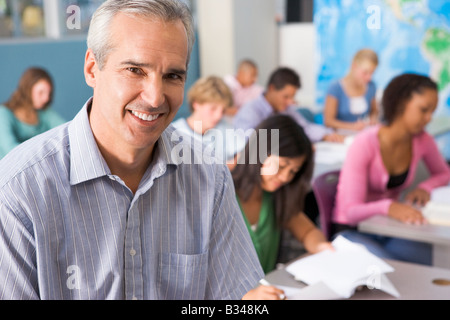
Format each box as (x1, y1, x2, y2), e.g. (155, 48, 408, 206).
(0, 202, 39, 300)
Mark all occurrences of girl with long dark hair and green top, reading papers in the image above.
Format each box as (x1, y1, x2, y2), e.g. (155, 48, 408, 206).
(236, 115, 332, 299)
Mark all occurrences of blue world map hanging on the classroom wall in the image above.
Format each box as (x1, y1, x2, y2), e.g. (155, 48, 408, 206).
(314, 0, 450, 158)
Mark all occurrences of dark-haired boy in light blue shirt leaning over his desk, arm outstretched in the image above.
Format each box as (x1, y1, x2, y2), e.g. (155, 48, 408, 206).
(233, 67, 344, 142)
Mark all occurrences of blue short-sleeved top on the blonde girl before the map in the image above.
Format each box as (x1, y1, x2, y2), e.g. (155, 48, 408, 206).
(327, 81, 376, 122)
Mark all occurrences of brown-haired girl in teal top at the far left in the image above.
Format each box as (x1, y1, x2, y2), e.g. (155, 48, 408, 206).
(0, 67, 65, 158)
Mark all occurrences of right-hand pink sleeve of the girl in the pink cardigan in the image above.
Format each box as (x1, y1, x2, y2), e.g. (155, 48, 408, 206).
(418, 133, 450, 192)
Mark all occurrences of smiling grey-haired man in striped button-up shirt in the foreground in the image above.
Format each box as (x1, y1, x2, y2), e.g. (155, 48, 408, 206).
(0, 0, 263, 299)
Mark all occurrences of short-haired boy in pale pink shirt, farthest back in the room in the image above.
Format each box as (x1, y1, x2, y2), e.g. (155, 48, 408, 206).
(224, 59, 264, 115)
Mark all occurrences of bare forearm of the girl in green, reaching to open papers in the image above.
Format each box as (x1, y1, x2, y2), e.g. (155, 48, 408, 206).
(287, 212, 333, 253)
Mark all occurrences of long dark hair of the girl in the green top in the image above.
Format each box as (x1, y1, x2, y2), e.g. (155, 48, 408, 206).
(231, 115, 314, 226)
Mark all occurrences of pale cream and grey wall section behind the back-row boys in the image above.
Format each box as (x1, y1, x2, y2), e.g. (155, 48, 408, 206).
(197, 0, 278, 85)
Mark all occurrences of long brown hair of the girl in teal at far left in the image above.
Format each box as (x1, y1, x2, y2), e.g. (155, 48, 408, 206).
(5, 67, 53, 111)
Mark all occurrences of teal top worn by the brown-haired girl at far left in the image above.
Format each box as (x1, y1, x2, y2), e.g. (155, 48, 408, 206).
(0, 105, 65, 159)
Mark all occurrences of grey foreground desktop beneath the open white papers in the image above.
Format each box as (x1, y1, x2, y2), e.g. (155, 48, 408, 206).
(265, 260, 450, 300)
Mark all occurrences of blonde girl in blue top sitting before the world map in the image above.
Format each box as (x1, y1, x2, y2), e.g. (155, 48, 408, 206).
(323, 49, 378, 131)
